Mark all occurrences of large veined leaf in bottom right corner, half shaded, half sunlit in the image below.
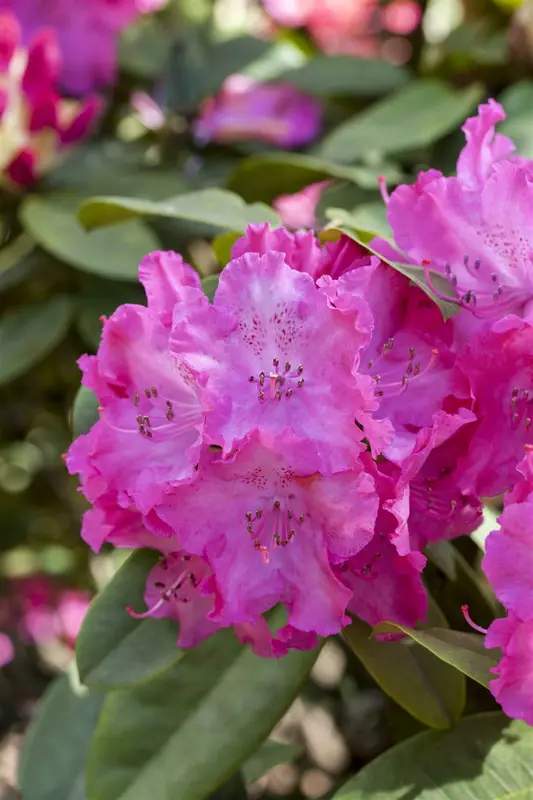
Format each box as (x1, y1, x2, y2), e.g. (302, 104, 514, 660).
(333, 711, 533, 800)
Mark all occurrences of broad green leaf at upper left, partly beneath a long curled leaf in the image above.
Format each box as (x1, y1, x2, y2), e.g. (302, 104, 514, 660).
(19, 193, 158, 281)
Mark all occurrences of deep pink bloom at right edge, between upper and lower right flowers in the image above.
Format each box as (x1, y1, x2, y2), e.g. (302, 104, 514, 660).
(450, 316, 533, 497)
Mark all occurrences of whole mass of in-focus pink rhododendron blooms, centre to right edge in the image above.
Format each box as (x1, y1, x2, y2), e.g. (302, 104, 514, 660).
(67, 101, 533, 724)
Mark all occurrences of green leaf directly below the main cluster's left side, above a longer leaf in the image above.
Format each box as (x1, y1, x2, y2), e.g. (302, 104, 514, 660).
(76, 550, 183, 689)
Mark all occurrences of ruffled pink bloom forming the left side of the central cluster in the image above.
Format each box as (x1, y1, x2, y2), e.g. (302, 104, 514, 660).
(67, 253, 204, 514)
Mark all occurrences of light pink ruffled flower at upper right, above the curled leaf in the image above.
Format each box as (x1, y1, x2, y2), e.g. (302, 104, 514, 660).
(387, 100, 533, 320)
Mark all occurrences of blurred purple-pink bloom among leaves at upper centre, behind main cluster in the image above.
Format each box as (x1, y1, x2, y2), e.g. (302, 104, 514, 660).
(194, 75, 322, 148)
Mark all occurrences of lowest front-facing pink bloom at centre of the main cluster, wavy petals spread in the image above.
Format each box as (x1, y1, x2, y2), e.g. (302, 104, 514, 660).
(158, 433, 378, 635)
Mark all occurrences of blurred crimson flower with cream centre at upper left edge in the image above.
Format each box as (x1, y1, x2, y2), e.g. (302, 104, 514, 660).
(0, 12, 100, 188)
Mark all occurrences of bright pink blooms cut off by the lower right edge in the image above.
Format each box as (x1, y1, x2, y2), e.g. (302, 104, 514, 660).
(483, 447, 533, 725)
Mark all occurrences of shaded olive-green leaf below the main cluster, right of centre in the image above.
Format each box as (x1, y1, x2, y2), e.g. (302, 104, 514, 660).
(343, 619, 466, 728)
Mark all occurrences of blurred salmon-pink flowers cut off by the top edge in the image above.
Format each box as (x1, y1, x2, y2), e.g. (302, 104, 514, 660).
(263, 0, 422, 57)
